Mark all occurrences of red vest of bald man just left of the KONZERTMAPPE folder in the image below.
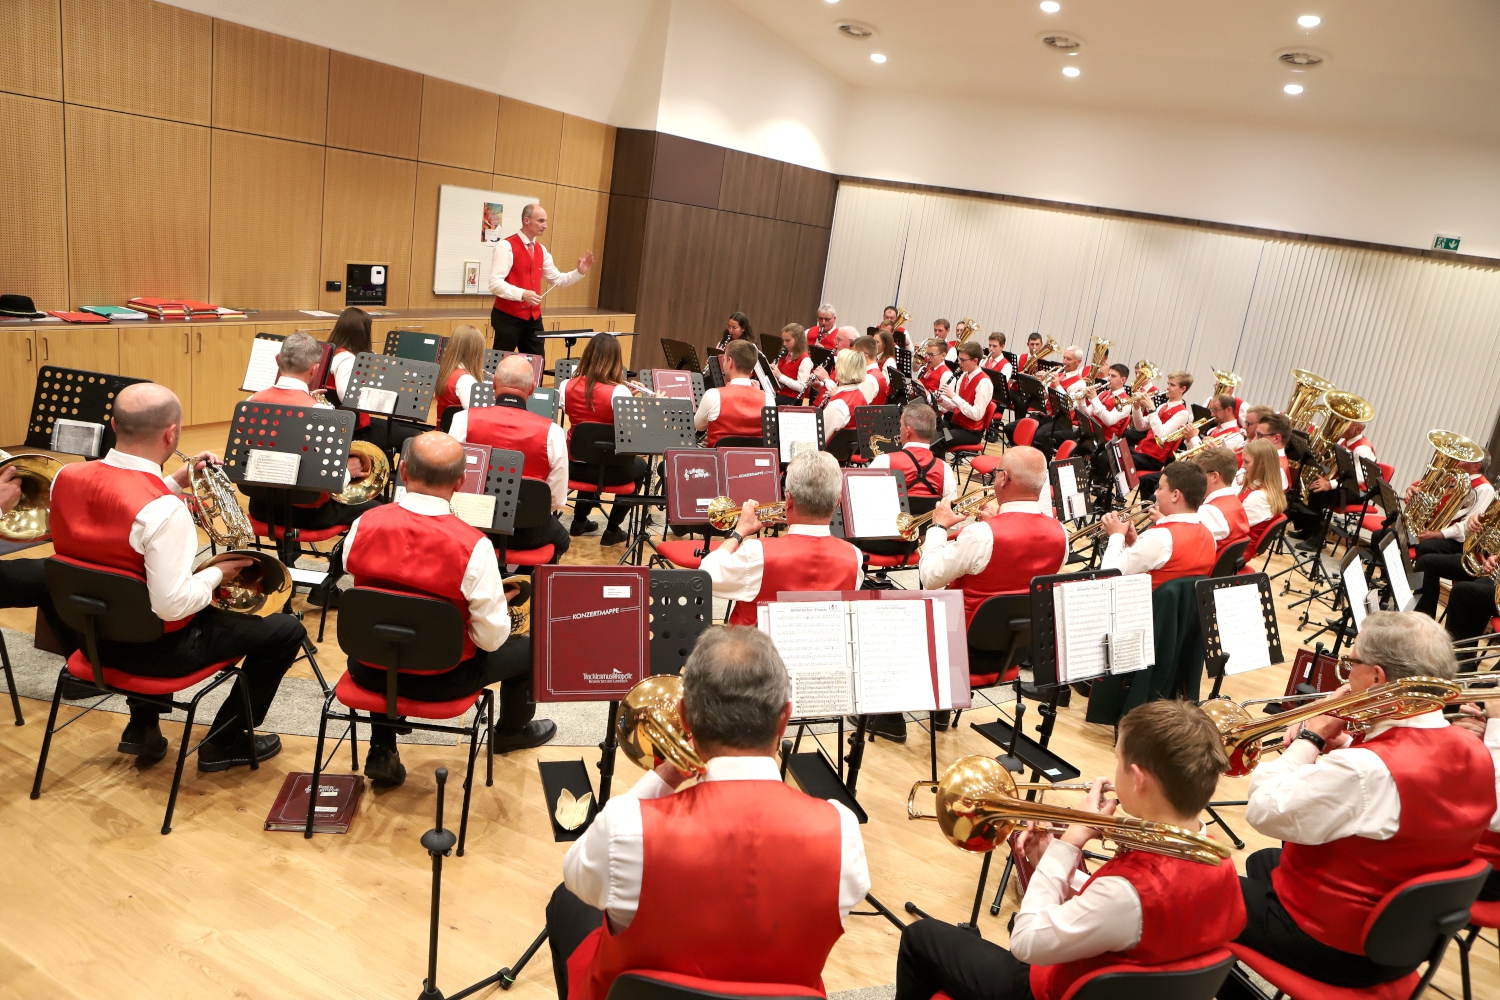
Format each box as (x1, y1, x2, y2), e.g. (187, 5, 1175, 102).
(344, 500, 485, 673)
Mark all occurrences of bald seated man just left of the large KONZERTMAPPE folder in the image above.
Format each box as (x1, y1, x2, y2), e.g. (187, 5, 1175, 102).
(344, 431, 555, 787)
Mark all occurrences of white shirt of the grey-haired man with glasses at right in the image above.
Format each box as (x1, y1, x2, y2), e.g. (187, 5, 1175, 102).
(1245, 712, 1500, 846)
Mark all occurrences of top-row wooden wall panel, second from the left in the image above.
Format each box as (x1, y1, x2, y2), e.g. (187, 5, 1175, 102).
(62, 0, 213, 124)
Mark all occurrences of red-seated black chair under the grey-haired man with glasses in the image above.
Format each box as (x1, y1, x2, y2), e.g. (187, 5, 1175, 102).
(1229, 861, 1490, 1000)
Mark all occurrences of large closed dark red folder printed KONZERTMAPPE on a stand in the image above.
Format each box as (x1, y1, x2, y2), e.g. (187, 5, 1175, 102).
(531, 565, 651, 702)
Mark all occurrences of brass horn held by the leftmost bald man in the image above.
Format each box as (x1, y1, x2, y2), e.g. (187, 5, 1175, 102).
(177, 451, 291, 618)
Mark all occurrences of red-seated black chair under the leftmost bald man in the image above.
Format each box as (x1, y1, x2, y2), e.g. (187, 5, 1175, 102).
(32, 556, 260, 834)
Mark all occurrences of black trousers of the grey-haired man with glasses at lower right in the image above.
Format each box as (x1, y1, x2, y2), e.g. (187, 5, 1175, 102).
(1218, 847, 1416, 1000)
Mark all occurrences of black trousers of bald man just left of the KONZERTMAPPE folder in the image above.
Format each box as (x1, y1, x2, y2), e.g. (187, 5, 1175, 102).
(350, 636, 537, 748)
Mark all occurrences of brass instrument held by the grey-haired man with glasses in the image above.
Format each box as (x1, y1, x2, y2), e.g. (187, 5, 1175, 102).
(1203, 678, 1461, 778)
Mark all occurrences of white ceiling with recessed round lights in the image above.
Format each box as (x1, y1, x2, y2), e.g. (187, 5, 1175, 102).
(723, 0, 1500, 142)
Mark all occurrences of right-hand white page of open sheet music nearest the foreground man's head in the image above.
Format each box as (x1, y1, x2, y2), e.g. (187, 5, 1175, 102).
(852, 599, 938, 715)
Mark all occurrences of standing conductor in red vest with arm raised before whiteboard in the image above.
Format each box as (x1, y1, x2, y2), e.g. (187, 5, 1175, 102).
(489, 202, 594, 355)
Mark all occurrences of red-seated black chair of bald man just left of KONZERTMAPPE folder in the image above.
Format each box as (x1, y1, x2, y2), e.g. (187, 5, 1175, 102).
(316, 586, 495, 858)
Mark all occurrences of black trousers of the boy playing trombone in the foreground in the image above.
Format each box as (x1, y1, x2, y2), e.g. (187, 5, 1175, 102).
(896, 919, 1032, 1000)
